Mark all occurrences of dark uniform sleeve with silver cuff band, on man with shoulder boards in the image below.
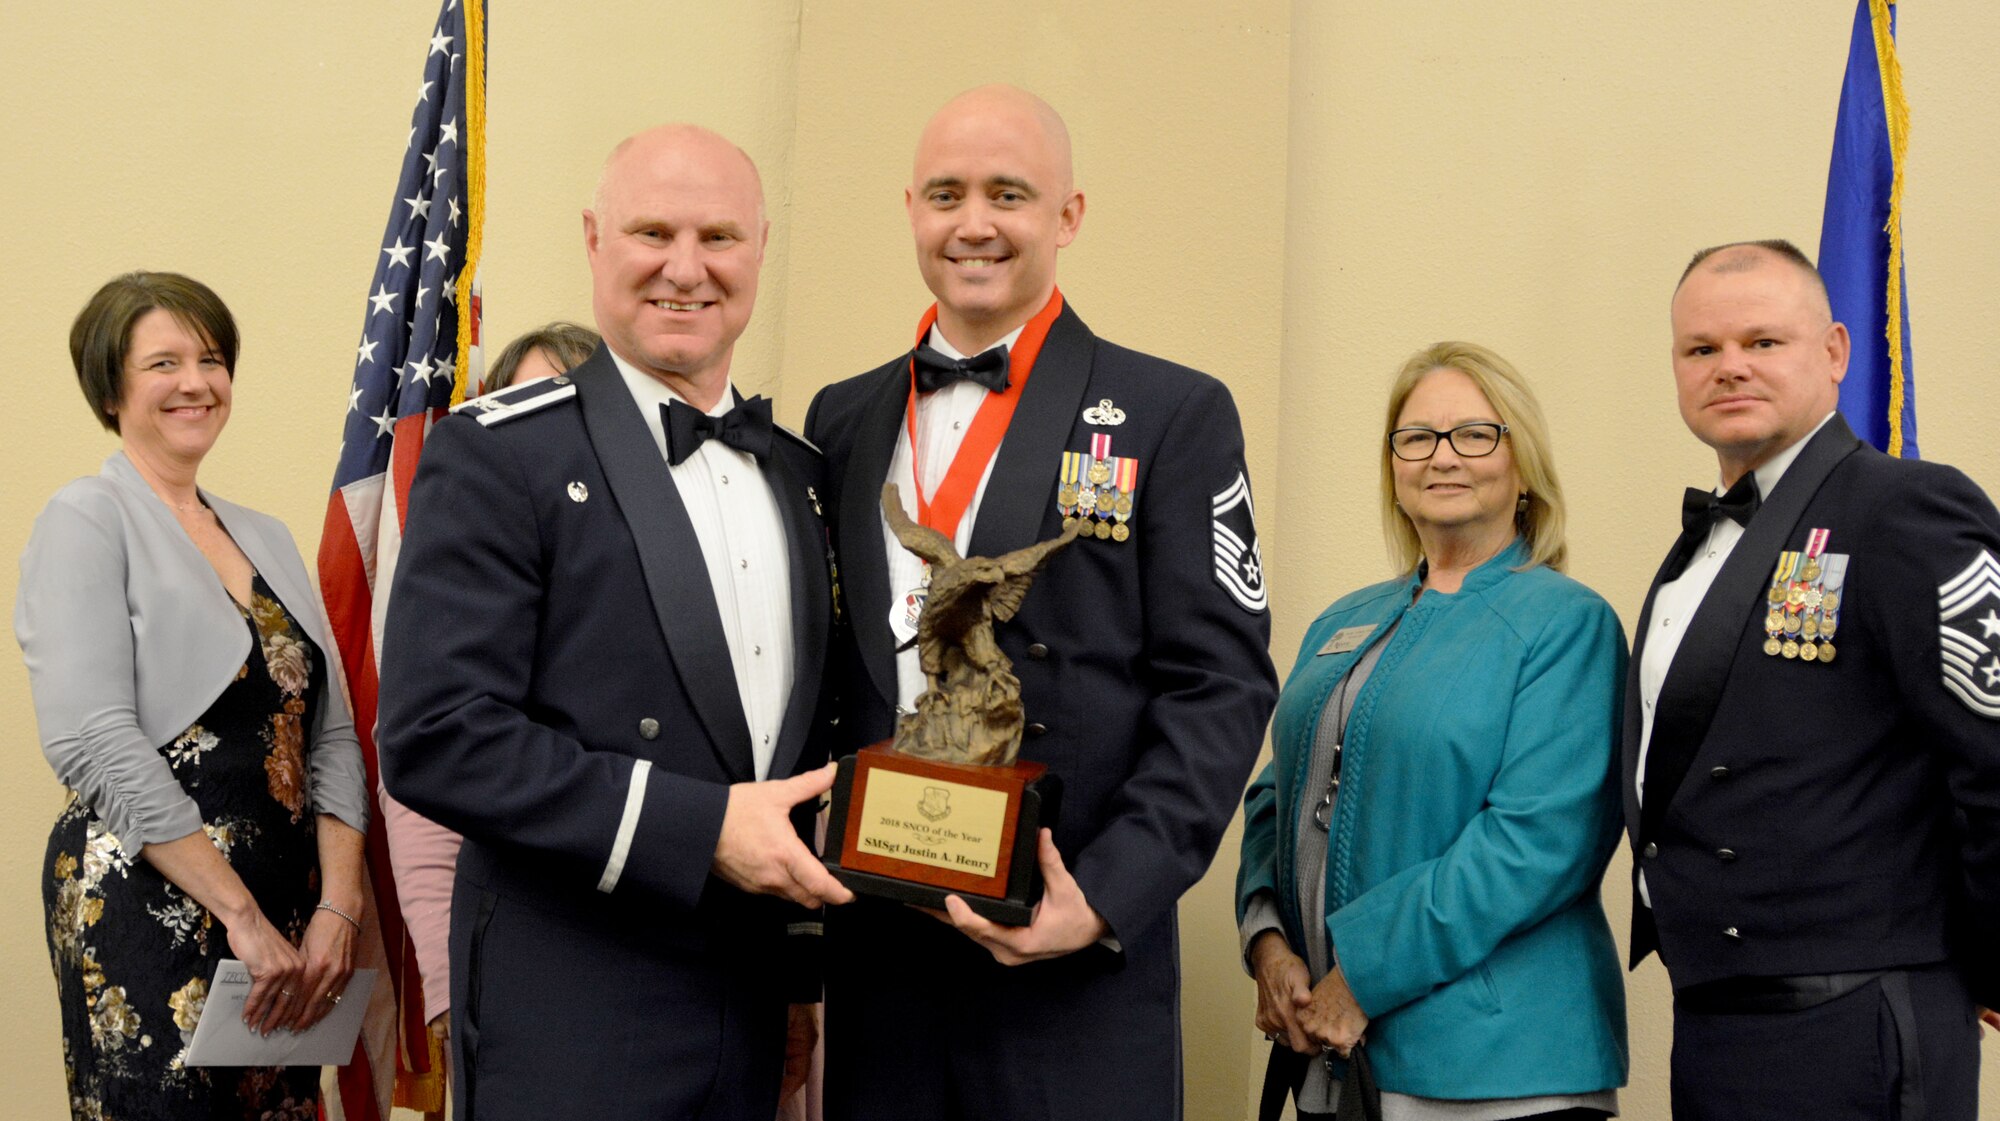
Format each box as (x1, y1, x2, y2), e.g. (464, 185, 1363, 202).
(382, 416, 728, 911)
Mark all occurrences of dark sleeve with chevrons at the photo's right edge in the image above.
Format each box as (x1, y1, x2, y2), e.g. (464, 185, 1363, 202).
(1876, 464, 2000, 1009)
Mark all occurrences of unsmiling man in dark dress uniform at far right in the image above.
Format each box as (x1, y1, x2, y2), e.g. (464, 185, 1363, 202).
(1624, 242, 2000, 1121)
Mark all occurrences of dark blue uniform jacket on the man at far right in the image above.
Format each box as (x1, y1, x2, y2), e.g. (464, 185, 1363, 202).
(1620, 416, 2000, 1007)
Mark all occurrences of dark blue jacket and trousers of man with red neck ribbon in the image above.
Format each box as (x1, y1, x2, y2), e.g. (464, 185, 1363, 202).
(806, 306, 1278, 1121)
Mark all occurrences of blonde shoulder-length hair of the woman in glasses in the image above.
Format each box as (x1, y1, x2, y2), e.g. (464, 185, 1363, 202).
(1382, 342, 1570, 573)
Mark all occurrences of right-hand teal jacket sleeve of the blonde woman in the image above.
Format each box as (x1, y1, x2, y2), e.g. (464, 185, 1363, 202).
(1326, 597, 1626, 1017)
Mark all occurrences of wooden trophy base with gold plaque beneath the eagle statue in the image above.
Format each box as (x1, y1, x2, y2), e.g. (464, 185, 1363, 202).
(824, 741, 1062, 927)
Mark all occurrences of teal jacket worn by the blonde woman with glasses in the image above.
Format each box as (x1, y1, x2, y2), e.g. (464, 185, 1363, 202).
(1236, 542, 1626, 1099)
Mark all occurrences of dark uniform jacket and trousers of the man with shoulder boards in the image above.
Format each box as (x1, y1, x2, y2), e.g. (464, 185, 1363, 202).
(380, 346, 832, 1121)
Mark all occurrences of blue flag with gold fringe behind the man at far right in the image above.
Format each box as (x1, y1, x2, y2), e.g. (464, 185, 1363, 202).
(1820, 0, 1916, 458)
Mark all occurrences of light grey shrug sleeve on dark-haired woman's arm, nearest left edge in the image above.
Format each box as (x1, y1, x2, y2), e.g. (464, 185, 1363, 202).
(14, 492, 202, 855)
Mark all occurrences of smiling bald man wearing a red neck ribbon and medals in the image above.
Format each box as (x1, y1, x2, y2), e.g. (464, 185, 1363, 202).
(806, 86, 1276, 1121)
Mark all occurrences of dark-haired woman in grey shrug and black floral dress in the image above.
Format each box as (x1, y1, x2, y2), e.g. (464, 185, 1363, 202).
(14, 272, 366, 1121)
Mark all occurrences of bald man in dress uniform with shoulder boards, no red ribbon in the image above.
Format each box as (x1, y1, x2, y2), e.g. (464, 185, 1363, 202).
(382, 126, 848, 1121)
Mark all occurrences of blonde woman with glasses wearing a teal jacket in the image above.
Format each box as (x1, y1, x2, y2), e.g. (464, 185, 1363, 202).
(1236, 342, 1626, 1121)
